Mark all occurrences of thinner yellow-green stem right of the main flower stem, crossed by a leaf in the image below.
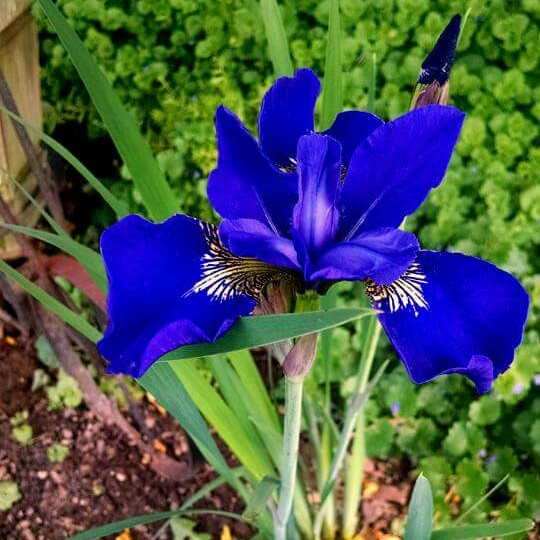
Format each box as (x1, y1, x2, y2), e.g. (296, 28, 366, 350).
(343, 317, 381, 538)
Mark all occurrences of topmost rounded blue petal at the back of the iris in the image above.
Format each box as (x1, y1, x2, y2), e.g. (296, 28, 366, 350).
(259, 68, 321, 167)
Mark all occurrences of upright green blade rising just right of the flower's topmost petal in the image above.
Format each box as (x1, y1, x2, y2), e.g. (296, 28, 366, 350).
(320, 0, 343, 131)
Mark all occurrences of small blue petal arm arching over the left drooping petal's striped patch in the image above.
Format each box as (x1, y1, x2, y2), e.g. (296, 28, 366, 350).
(219, 219, 299, 270)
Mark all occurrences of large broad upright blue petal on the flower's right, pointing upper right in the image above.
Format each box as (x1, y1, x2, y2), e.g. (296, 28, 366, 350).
(340, 105, 465, 239)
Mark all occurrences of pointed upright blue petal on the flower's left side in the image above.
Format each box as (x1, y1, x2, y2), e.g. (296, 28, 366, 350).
(208, 107, 298, 233)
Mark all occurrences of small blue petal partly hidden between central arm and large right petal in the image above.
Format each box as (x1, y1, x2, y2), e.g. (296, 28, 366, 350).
(324, 111, 384, 167)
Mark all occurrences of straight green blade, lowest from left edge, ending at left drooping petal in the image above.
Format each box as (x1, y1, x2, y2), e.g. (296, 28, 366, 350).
(0, 260, 101, 343)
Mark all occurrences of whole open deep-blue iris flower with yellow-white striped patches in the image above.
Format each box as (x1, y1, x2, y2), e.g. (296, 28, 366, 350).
(99, 69, 529, 392)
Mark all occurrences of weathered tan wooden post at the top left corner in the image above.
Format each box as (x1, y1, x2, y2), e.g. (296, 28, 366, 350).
(0, 0, 42, 258)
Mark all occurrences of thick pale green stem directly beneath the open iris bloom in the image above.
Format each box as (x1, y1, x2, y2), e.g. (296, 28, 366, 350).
(275, 378, 304, 540)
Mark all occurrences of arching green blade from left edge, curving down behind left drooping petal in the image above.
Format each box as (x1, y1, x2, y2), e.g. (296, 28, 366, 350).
(0, 223, 107, 292)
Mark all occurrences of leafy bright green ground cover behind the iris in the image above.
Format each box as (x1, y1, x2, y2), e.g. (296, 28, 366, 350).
(35, 0, 540, 519)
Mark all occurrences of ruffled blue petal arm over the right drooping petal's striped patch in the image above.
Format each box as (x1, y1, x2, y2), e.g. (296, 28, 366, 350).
(310, 229, 418, 283)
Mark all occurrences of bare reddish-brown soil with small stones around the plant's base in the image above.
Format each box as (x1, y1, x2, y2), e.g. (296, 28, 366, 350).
(0, 342, 410, 540)
